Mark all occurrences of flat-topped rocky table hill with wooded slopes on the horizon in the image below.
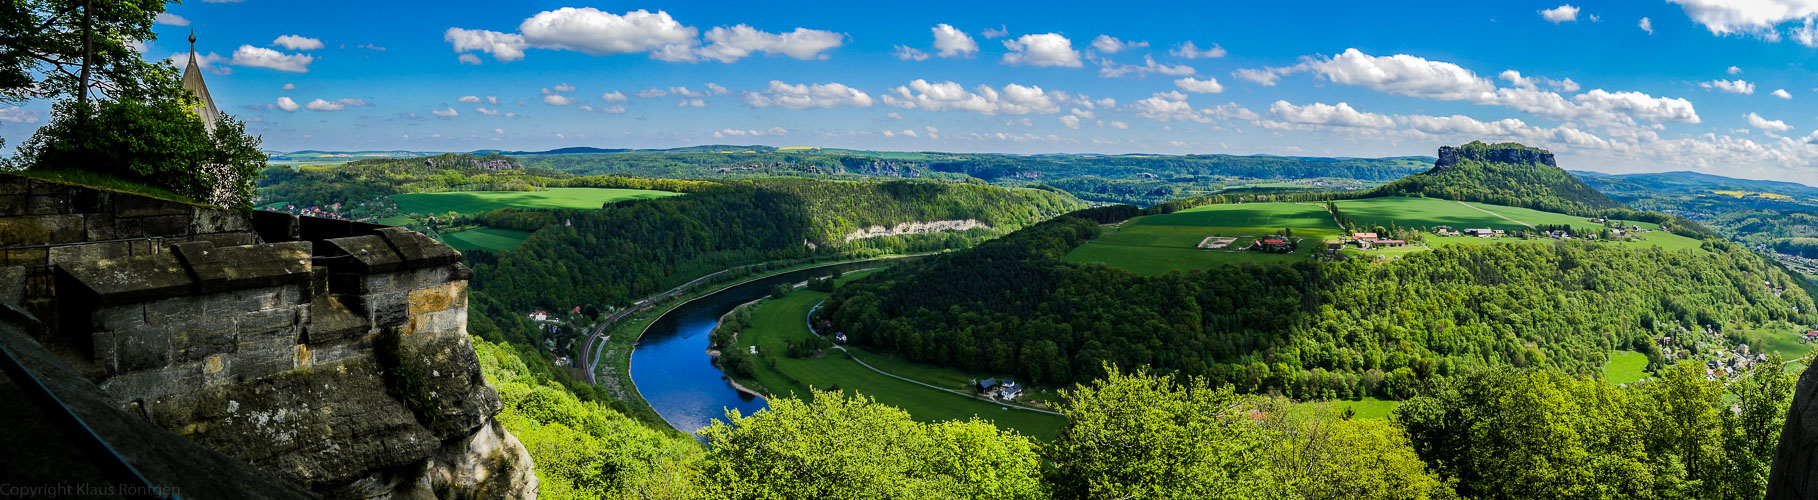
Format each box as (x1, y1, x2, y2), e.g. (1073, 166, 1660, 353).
(1365, 142, 1623, 215)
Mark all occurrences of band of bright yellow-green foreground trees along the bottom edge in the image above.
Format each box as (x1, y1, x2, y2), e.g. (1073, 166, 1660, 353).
(474, 329, 1793, 498)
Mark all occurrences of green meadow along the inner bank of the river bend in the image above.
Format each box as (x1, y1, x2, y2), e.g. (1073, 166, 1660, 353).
(727, 275, 1065, 440)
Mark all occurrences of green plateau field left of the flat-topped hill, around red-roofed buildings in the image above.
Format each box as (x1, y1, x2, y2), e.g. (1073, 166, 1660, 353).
(1065, 204, 1338, 275)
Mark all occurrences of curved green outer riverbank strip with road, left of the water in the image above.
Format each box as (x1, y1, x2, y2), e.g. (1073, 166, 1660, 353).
(594, 253, 934, 435)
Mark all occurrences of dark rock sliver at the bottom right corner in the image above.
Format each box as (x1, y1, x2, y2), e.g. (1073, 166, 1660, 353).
(1767, 367, 1818, 500)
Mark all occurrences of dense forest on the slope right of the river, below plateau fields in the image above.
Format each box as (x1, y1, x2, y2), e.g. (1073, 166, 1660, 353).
(820, 216, 1818, 398)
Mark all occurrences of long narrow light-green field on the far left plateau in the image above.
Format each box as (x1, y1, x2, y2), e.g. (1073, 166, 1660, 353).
(391, 187, 678, 215)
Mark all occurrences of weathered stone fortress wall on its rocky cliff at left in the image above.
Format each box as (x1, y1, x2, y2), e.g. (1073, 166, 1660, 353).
(0, 176, 536, 498)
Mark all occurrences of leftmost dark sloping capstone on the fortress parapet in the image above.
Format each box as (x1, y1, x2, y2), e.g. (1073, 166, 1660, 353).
(56, 253, 200, 305)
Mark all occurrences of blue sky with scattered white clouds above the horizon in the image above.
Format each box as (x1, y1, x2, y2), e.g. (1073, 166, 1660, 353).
(0, 0, 1818, 184)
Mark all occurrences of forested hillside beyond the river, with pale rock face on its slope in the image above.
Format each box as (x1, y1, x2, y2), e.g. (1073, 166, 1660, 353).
(471, 180, 1084, 316)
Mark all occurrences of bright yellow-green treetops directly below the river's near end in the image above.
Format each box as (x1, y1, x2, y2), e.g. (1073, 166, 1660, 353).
(700, 391, 1045, 498)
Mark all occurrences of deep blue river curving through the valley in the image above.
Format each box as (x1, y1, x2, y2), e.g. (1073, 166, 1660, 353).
(631, 260, 916, 433)
